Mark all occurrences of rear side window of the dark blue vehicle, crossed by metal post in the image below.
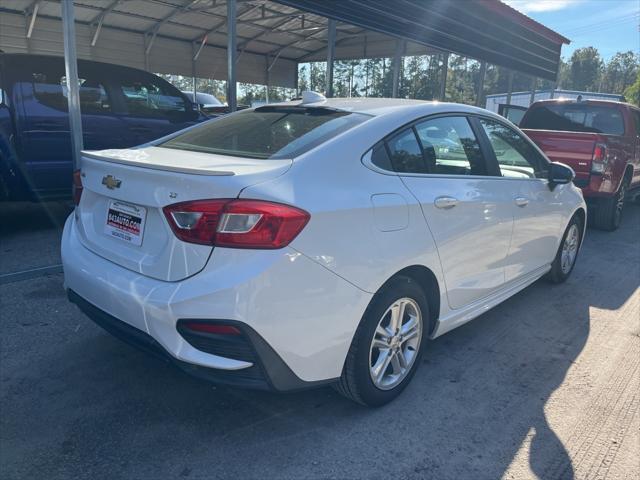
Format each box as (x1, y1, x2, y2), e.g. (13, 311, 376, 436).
(32, 71, 111, 113)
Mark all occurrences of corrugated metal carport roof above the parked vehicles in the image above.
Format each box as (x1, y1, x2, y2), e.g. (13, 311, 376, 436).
(0, 0, 566, 86)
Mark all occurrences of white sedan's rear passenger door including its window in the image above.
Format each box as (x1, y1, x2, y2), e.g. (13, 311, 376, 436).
(387, 115, 513, 309)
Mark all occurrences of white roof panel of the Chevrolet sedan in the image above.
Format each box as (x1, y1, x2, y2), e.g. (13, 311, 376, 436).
(280, 97, 491, 116)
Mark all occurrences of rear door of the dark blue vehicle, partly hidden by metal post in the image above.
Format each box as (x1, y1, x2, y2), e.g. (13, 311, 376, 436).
(19, 58, 124, 195)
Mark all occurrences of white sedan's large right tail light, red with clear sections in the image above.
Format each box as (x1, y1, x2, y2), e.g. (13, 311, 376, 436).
(163, 199, 310, 249)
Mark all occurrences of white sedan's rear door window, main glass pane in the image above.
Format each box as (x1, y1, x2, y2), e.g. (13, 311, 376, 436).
(416, 116, 486, 175)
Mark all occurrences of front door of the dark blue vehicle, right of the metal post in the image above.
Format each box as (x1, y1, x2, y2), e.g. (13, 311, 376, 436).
(117, 69, 199, 146)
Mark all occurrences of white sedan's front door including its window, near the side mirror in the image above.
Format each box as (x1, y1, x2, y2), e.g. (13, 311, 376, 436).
(477, 117, 567, 282)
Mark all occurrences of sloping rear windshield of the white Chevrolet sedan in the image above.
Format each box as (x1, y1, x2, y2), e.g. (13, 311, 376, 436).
(160, 106, 370, 159)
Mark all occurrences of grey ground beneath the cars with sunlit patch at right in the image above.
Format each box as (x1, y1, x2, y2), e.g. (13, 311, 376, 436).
(0, 201, 640, 480)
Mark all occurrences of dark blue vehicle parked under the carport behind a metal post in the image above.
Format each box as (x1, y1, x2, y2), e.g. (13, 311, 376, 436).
(0, 53, 207, 200)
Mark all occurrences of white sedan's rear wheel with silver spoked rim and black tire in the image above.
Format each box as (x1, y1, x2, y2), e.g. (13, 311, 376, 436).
(336, 276, 429, 407)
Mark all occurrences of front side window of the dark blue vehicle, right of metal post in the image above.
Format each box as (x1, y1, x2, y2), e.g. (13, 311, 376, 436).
(120, 78, 187, 117)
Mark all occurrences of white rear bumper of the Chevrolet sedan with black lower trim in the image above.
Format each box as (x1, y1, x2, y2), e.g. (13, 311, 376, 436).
(62, 214, 371, 390)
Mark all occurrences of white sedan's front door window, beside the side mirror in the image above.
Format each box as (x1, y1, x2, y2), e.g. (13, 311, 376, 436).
(480, 118, 546, 178)
